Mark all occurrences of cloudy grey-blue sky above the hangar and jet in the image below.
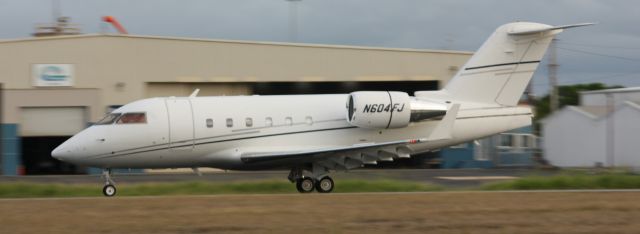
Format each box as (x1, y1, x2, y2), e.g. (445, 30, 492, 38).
(0, 0, 640, 95)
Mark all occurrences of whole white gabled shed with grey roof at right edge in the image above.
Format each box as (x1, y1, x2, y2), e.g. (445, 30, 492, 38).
(542, 87, 640, 167)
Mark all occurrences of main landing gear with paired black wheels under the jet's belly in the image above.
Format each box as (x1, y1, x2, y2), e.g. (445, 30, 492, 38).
(289, 168, 335, 193)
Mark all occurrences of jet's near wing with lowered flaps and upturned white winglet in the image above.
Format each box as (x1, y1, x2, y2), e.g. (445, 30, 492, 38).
(240, 104, 460, 170)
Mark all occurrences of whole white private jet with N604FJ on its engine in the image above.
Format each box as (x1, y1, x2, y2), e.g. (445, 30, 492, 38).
(52, 22, 590, 196)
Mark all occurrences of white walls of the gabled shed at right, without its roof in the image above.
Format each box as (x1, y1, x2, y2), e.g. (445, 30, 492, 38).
(542, 103, 640, 168)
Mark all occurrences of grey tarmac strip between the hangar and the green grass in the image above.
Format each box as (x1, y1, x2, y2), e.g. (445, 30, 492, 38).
(0, 169, 556, 188)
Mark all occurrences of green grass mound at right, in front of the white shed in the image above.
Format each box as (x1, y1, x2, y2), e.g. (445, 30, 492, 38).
(481, 171, 640, 190)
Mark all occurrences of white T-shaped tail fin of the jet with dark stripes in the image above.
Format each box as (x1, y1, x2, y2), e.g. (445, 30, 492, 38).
(442, 22, 591, 106)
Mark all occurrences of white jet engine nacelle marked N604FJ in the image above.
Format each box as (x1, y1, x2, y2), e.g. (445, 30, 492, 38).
(347, 91, 447, 129)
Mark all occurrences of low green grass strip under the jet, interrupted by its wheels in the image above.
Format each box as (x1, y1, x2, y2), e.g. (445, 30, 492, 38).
(0, 180, 442, 198)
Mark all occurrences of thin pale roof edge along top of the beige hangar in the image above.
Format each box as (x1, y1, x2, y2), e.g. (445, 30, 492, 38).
(0, 34, 473, 55)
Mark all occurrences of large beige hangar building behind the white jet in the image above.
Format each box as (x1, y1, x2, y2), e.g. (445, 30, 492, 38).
(0, 34, 472, 175)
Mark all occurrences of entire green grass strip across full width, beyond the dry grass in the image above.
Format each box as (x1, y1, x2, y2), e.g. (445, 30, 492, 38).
(0, 170, 640, 198)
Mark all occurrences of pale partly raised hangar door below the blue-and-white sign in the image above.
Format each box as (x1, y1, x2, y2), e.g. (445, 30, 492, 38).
(19, 107, 87, 137)
